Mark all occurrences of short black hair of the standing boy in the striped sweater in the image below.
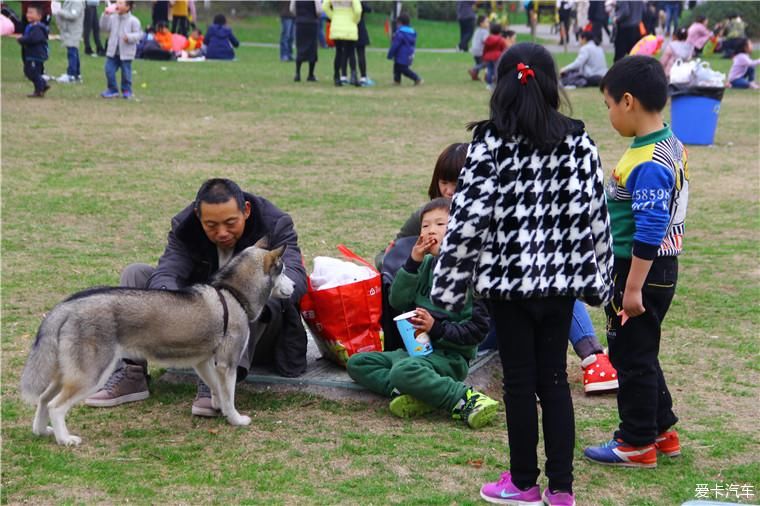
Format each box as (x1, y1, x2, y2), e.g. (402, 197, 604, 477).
(599, 55, 668, 112)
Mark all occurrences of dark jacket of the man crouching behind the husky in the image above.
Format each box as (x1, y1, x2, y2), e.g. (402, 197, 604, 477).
(148, 193, 306, 376)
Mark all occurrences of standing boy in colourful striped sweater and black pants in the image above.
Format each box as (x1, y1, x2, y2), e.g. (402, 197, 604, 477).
(584, 56, 689, 468)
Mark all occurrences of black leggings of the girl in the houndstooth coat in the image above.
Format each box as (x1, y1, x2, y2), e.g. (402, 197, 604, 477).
(489, 297, 575, 491)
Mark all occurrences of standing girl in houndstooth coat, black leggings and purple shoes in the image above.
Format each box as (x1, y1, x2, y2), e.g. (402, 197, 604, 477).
(430, 43, 612, 506)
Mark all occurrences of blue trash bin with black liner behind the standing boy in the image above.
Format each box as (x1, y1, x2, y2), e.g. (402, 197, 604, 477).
(670, 86, 724, 145)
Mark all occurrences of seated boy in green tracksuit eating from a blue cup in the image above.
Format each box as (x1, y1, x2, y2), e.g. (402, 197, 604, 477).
(347, 198, 499, 428)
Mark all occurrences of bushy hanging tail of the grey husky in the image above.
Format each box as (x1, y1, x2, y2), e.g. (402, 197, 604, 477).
(21, 310, 66, 404)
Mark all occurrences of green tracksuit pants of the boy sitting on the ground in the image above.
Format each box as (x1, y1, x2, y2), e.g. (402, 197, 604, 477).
(347, 350, 469, 411)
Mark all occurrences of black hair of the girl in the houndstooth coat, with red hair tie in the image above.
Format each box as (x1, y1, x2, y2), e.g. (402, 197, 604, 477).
(468, 42, 583, 151)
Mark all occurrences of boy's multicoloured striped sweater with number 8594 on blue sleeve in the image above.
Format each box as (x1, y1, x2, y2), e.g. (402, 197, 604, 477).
(607, 125, 689, 260)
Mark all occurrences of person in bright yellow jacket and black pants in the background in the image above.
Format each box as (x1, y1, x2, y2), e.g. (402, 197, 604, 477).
(322, 0, 362, 86)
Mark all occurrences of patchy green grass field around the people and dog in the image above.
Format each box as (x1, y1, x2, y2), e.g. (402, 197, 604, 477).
(1, 15, 760, 505)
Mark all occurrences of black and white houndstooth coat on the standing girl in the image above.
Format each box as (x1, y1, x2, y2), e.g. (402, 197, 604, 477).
(431, 122, 613, 311)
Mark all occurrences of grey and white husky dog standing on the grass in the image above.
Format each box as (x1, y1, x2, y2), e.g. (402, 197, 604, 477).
(21, 243, 293, 446)
